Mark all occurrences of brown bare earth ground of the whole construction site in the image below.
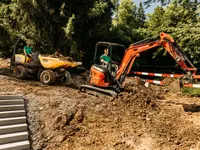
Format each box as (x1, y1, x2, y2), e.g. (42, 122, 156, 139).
(0, 59, 200, 150)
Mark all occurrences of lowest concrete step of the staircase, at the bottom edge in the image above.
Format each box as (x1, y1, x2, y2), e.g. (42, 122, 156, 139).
(0, 141, 30, 150)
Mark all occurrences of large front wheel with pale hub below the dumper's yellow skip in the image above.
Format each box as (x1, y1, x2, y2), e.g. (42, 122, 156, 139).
(40, 70, 56, 84)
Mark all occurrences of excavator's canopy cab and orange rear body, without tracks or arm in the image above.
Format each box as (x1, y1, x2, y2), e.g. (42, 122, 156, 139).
(90, 42, 125, 87)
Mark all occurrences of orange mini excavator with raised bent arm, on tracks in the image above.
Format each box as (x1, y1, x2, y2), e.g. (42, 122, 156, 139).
(80, 33, 197, 97)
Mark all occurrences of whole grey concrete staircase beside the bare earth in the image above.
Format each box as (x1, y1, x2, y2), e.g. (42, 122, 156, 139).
(0, 95, 30, 150)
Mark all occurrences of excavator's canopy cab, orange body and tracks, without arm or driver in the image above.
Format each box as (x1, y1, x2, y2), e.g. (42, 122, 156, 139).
(80, 42, 125, 97)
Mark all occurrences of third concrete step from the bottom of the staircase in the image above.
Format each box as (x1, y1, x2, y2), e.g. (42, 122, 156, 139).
(0, 123, 27, 135)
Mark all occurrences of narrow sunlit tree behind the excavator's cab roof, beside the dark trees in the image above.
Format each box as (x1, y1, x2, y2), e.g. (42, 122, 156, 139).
(111, 0, 140, 46)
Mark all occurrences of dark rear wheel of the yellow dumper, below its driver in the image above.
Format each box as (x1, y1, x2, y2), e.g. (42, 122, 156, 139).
(13, 65, 27, 79)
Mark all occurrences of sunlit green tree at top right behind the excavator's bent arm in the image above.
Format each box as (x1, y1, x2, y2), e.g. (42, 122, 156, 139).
(146, 0, 200, 63)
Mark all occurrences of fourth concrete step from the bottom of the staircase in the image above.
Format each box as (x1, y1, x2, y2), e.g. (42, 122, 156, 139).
(0, 116, 26, 126)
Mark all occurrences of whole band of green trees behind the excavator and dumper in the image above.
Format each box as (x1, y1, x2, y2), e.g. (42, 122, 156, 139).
(0, 0, 200, 66)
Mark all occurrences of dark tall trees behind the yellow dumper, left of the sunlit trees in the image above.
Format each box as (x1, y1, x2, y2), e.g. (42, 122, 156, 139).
(0, 0, 114, 64)
